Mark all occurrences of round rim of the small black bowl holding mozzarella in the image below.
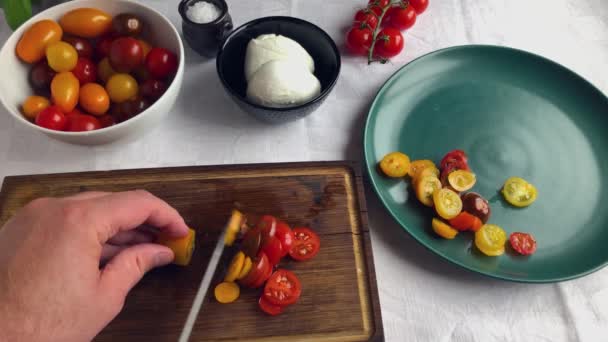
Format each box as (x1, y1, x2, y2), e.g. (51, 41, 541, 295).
(215, 16, 342, 113)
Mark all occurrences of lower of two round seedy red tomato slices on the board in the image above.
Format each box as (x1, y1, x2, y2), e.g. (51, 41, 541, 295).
(263, 269, 302, 306)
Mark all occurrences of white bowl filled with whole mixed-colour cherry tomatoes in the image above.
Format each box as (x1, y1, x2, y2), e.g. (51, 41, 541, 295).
(0, 0, 185, 145)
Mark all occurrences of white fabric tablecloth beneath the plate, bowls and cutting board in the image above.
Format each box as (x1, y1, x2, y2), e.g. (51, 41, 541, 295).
(0, 0, 608, 342)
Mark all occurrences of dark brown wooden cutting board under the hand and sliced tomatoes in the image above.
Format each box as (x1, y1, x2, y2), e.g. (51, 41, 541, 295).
(0, 162, 384, 341)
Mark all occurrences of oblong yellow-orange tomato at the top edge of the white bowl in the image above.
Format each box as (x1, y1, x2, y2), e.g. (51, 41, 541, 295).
(59, 8, 112, 38)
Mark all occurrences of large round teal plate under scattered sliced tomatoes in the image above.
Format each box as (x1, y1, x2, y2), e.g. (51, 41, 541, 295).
(364, 46, 608, 283)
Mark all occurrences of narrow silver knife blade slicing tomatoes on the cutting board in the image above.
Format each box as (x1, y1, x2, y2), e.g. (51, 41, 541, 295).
(179, 225, 230, 342)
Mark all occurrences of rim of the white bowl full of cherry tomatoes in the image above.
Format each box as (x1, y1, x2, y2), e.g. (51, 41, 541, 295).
(0, 0, 185, 137)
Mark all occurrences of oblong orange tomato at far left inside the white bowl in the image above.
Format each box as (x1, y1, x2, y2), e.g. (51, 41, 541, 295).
(16, 20, 63, 63)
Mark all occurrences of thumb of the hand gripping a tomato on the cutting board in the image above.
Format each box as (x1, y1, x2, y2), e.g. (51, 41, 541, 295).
(100, 243, 174, 303)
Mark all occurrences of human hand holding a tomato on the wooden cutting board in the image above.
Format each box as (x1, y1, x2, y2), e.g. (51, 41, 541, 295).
(0, 190, 188, 341)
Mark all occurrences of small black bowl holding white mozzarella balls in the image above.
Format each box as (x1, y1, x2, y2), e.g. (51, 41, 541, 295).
(216, 16, 341, 123)
